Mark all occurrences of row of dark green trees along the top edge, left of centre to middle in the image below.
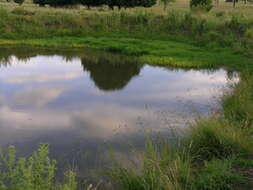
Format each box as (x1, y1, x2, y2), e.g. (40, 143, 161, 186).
(33, 0, 156, 9)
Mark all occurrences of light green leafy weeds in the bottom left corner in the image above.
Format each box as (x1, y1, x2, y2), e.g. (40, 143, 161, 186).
(0, 144, 77, 190)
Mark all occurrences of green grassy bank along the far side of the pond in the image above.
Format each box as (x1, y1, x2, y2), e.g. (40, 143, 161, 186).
(0, 4, 253, 69)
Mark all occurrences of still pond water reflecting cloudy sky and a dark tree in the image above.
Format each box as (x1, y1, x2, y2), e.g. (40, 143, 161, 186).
(0, 50, 237, 178)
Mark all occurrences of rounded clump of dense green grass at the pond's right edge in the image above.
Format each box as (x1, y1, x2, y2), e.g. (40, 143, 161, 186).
(183, 118, 253, 163)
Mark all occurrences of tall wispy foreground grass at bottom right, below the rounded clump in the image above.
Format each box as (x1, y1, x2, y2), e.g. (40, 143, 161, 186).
(105, 132, 249, 190)
